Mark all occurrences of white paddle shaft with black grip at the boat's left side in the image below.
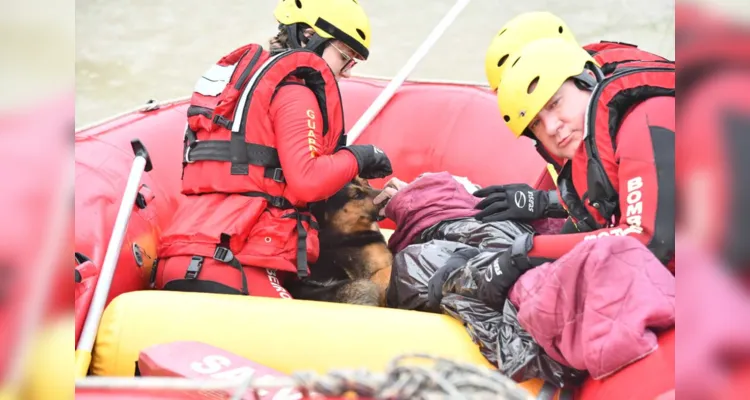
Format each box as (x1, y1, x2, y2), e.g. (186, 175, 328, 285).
(76, 139, 152, 377)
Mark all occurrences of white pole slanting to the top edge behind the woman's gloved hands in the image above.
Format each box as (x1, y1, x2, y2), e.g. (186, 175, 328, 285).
(346, 0, 471, 145)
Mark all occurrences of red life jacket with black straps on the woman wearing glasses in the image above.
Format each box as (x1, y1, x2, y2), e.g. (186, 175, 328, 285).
(159, 44, 344, 284)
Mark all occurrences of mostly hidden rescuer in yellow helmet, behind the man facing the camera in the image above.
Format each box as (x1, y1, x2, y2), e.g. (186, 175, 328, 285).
(484, 11, 668, 233)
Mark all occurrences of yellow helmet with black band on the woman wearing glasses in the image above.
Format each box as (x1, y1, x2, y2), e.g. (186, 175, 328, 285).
(273, 0, 371, 60)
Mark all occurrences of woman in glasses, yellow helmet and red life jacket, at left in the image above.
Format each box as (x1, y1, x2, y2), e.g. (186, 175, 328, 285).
(154, 0, 392, 298)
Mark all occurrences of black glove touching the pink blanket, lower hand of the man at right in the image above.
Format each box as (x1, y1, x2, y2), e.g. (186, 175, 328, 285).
(474, 233, 542, 312)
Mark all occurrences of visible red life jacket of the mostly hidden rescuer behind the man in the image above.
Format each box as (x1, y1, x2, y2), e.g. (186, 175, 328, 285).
(536, 40, 671, 173)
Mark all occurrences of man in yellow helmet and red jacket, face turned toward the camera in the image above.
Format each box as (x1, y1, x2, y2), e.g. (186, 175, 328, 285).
(431, 38, 675, 310)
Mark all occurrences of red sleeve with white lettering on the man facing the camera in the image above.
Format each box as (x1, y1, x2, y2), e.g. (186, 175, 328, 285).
(529, 97, 675, 264)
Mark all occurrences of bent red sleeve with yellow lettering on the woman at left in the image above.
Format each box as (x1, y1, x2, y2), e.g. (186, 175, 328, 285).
(270, 85, 358, 203)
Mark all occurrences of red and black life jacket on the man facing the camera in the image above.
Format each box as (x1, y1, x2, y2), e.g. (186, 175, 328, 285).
(557, 61, 675, 232)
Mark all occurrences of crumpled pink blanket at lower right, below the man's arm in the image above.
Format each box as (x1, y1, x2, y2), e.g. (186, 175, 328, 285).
(510, 236, 675, 379)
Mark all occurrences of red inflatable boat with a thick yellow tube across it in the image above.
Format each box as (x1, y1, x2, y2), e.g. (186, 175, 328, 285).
(75, 77, 674, 399)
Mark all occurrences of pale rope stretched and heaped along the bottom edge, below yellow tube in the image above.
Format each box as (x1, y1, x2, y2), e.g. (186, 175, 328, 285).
(76, 354, 533, 400)
